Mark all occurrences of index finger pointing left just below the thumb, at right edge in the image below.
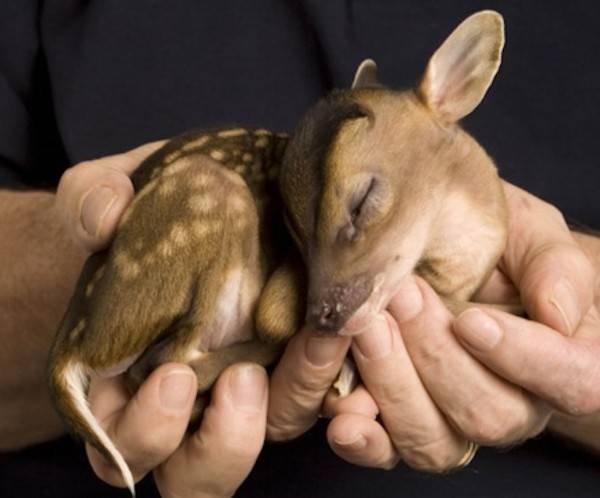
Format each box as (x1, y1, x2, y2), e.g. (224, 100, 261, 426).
(454, 307, 600, 415)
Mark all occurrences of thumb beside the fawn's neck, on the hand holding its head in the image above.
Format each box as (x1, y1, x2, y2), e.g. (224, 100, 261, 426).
(500, 183, 596, 335)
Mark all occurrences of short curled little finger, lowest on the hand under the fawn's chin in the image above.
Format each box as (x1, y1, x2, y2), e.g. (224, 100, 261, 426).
(327, 413, 399, 469)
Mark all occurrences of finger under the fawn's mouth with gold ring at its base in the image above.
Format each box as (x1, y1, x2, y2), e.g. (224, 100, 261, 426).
(352, 281, 466, 472)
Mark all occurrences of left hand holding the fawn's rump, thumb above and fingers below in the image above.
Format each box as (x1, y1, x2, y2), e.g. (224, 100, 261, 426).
(55, 141, 268, 498)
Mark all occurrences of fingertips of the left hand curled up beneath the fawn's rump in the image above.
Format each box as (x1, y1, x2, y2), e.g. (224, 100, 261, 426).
(87, 363, 268, 498)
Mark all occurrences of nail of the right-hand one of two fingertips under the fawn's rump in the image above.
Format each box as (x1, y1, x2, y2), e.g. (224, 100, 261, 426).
(229, 364, 267, 413)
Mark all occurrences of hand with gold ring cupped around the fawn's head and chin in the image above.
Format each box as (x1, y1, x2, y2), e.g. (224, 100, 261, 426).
(269, 180, 600, 471)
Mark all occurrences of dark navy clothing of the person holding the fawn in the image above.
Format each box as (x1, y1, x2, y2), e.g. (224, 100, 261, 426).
(0, 0, 600, 498)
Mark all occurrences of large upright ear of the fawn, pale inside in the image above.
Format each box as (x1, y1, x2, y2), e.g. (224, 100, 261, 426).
(418, 10, 504, 123)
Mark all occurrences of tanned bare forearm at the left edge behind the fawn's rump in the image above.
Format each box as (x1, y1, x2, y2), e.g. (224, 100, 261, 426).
(0, 191, 85, 450)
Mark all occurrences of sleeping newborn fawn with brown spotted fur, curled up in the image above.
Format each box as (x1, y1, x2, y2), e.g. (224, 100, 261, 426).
(50, 12, 506, 491)
